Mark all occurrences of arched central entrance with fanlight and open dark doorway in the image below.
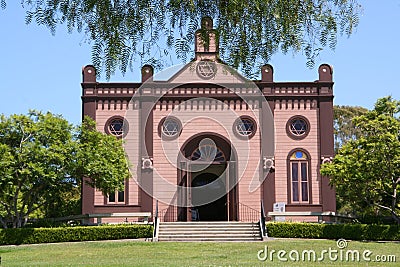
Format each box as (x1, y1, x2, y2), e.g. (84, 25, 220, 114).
(178, 133, 238, 221)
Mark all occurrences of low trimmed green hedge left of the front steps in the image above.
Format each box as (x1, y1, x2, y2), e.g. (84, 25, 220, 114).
(0, 225, 153, 245)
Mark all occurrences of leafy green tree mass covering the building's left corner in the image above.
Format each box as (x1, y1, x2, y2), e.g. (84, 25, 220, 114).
(0, 111, 129, 228)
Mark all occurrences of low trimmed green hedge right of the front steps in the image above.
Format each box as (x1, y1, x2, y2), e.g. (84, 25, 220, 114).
(267, 223, 400, 241)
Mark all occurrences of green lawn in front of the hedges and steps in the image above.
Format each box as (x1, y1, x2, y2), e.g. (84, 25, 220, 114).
(0, 239, 400, 267)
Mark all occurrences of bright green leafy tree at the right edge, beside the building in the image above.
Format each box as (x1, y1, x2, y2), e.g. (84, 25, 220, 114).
(321, 97, 400, 223)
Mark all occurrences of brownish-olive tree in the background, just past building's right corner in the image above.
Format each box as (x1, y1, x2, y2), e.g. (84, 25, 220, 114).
(333, 106, 368, 153)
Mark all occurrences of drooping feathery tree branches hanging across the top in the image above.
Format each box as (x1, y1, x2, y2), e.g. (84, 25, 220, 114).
(1, 0, 361, 78)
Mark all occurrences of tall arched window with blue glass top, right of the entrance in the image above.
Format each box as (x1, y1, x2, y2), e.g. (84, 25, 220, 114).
(288, 149, 310, 203)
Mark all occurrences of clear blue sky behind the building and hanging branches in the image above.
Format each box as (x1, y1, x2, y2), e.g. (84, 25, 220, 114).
(0, 0, 400, 124)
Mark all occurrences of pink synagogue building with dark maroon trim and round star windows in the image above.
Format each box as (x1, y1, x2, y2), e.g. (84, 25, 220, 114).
(82, 17, 336, 225)
